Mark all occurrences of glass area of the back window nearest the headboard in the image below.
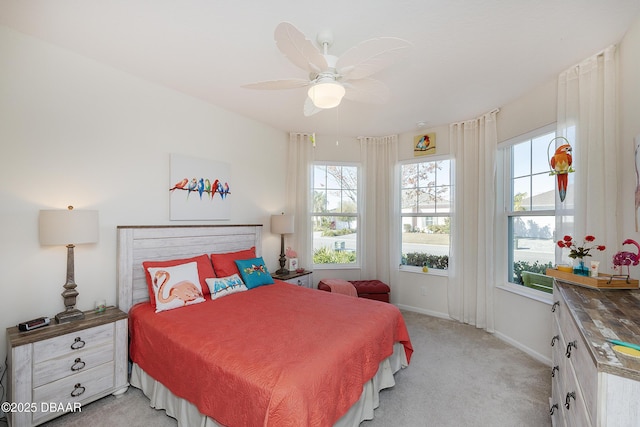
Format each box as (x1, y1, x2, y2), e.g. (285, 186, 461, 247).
(311, 164, 359, 265)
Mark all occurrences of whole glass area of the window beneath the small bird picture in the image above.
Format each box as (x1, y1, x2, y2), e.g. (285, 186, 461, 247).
(400, 159, 452, 270)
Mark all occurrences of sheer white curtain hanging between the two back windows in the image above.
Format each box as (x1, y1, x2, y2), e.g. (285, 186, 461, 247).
(358, 135, 400, 284)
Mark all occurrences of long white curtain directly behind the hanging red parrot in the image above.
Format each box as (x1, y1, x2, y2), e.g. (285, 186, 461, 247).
(557, 46, 622, 269)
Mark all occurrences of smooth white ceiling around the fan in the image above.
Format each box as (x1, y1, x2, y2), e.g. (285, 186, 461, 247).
(0, 0, 640, 137)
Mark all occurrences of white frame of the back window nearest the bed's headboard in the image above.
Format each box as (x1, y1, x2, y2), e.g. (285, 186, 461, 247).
(307, 160, 364, 270)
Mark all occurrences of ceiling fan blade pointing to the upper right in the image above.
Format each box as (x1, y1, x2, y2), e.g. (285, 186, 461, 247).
(336, 37, 412, 80)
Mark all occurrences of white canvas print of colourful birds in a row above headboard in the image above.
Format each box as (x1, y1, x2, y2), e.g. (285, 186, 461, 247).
(168, 154, 233, 221)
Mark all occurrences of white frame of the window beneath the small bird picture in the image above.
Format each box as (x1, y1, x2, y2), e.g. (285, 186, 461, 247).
(397, 154, 455, 276)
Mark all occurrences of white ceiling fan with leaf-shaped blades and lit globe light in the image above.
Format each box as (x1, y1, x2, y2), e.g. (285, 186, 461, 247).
(242, 22, 411, 116)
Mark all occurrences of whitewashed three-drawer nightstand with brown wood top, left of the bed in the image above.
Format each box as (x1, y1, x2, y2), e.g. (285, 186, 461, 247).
(7, 307, 129, 427)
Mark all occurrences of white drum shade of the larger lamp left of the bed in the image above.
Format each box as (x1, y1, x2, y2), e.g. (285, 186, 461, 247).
(39, 206, 99, 245)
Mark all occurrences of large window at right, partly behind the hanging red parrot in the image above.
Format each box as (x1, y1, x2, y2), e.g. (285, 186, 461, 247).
(504, 127, 571, 293)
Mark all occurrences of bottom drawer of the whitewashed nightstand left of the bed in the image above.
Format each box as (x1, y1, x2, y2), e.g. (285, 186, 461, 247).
(33, 362, 114, 424)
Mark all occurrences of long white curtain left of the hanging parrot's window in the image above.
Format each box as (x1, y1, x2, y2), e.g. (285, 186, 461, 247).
(448, 110, 498, 332)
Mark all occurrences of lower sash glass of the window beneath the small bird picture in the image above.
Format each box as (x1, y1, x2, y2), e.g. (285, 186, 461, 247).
(402, 217, 451, 270)
